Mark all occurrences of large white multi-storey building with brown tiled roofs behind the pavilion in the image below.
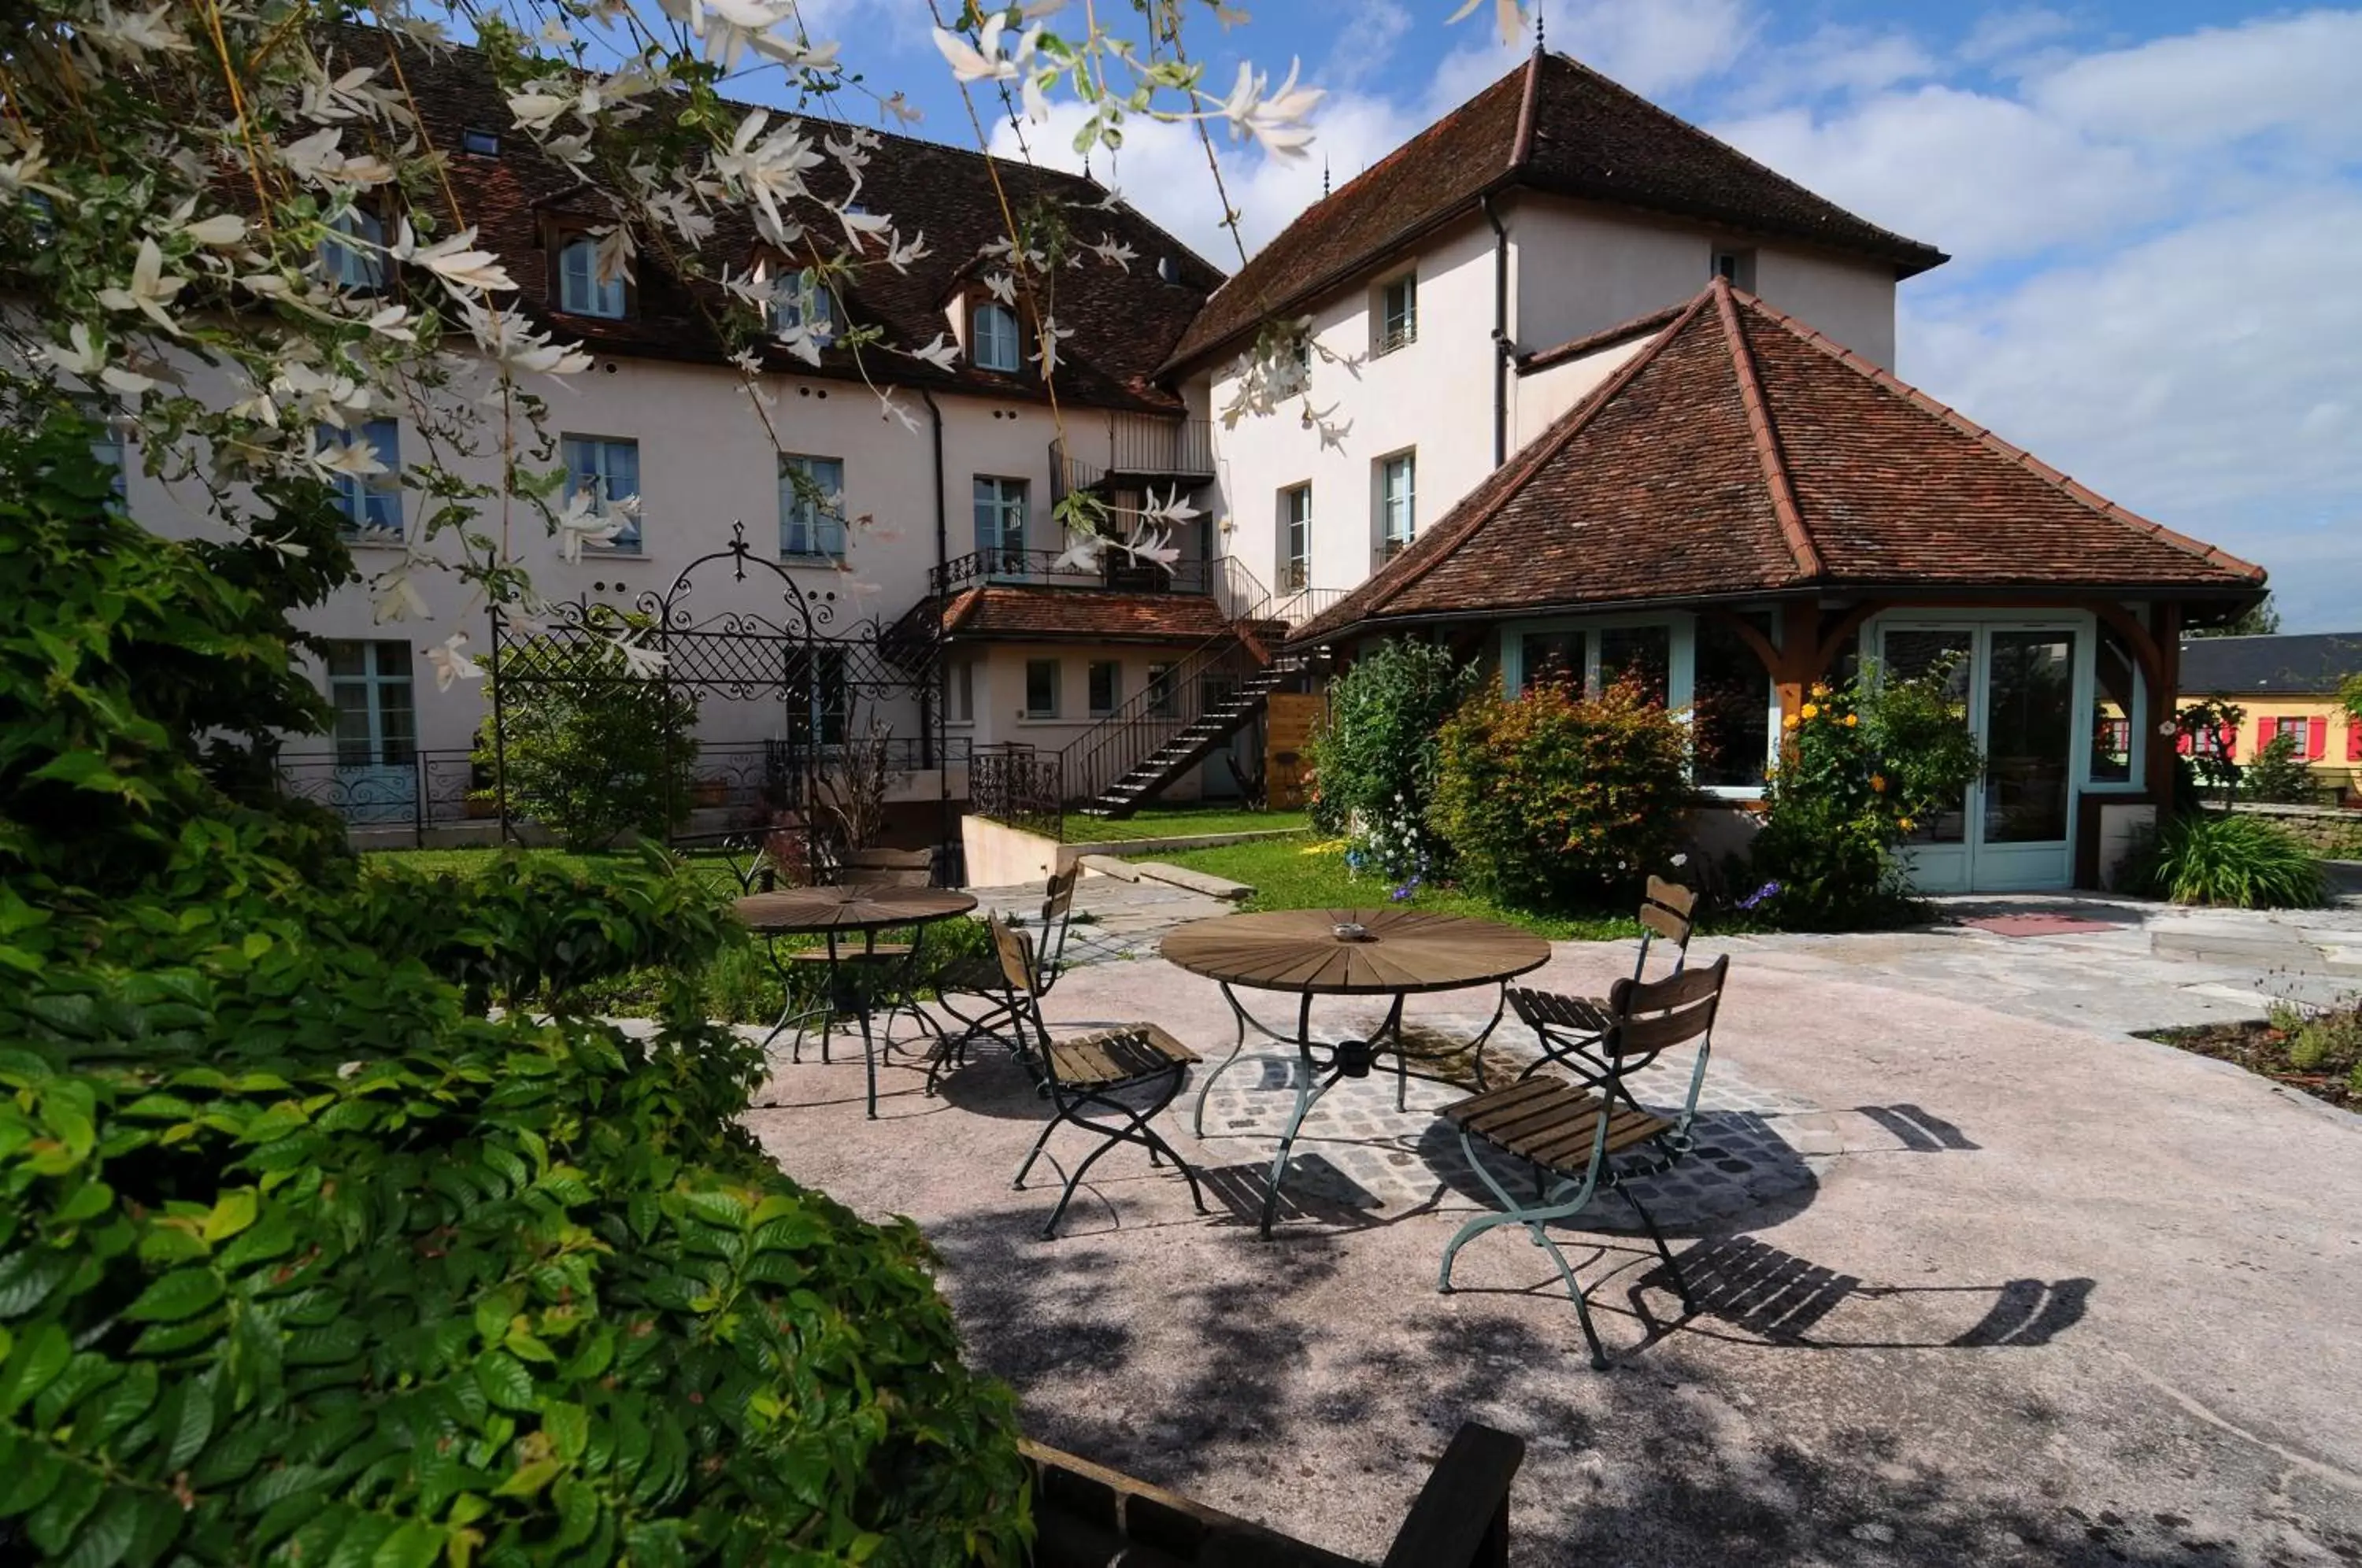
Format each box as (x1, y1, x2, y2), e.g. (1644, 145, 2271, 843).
(130, 36, 1984, 850)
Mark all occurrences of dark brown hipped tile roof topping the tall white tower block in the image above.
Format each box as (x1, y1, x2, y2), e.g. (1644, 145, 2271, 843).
(1167, 52, 1946, 368)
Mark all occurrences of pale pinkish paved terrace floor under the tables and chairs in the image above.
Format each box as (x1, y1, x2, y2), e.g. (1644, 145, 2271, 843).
(749, 912, 2362, 1566)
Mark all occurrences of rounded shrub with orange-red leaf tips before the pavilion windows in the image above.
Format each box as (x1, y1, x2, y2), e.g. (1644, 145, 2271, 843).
(1429, 680, 1691, 909)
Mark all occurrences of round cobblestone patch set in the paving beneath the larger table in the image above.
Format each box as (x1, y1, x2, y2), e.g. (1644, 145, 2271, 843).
(1176, 1015, 1842, 1230)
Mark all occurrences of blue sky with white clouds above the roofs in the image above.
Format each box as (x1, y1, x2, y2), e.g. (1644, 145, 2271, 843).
(723, 0, 2362, 631)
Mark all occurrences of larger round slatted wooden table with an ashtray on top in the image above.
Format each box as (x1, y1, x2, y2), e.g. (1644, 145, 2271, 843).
(1162, 909, 1549, 1240)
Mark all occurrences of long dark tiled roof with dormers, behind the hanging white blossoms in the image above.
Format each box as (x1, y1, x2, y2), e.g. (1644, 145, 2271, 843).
(373, 28, 1221, 411)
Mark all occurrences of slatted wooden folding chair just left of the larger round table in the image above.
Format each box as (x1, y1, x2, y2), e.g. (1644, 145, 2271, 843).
(985, 914, 1207, 1240)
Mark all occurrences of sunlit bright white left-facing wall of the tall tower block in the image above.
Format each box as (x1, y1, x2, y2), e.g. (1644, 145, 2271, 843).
(1190, 220, 1493, 588)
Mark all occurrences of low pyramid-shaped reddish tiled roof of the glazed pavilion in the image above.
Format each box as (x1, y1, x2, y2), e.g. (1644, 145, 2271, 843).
(1294, 279, 2263, 642)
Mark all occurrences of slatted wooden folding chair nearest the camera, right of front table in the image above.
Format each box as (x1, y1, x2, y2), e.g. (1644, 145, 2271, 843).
(1436, 956, 1731, 1370)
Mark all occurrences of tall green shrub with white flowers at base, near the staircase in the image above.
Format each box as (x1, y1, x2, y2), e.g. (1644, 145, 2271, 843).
(1306, 638, 1479, 878)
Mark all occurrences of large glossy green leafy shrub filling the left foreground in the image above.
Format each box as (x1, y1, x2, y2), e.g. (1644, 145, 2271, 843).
(0, 420, 1030, 1568)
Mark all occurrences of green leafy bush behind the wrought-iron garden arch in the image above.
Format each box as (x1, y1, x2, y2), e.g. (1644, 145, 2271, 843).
(477, 628, 697, 850)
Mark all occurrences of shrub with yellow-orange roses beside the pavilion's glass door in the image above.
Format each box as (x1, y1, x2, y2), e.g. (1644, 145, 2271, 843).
(1741, 668, 1984, 930)
